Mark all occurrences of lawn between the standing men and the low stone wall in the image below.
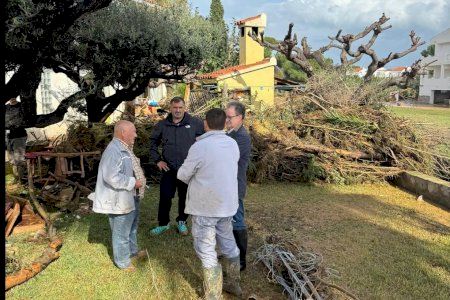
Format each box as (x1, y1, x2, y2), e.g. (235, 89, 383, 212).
(247, 184, 450, 299)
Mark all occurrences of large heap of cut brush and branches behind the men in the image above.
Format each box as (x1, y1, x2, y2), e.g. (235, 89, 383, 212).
(249, 70, 450, 183)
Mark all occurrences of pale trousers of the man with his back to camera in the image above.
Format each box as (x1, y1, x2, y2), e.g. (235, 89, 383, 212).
(191, 216, 239, 269)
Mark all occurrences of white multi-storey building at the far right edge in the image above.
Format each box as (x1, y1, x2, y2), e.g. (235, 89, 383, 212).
(419, 28, 450, 104)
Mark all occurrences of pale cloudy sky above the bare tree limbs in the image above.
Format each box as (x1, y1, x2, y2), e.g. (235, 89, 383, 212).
(190, 0, 450, 68)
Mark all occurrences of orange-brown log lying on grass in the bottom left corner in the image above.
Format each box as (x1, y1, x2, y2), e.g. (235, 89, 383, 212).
(5, 239, 62, 291)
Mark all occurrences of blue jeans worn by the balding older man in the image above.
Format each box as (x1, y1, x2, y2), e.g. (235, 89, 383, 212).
(108, 197, 139, 269)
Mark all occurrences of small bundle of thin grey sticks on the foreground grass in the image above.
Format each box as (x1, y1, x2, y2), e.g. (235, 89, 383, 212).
(255, 236, 357, 300)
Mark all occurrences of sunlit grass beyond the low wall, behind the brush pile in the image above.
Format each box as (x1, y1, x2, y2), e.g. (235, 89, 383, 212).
(389, 106, 450, 156)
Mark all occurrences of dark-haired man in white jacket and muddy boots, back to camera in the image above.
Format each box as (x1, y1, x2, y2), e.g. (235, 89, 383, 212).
(177, 108, 242, 299)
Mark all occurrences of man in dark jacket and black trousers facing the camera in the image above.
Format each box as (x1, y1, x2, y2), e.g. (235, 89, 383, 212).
(150, 97, 204, 235)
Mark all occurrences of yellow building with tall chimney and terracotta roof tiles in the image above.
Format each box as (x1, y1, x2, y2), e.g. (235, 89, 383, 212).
(198, 13, 277, 105)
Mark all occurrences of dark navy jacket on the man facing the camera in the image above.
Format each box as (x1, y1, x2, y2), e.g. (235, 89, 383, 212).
(150, 113, 205, 170)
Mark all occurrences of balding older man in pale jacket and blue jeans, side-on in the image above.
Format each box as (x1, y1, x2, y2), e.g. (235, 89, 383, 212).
(93, 120, 146, 271)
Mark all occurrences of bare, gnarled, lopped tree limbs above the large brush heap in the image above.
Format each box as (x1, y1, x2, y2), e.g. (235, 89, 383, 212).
(249, 14, 432, 88)
